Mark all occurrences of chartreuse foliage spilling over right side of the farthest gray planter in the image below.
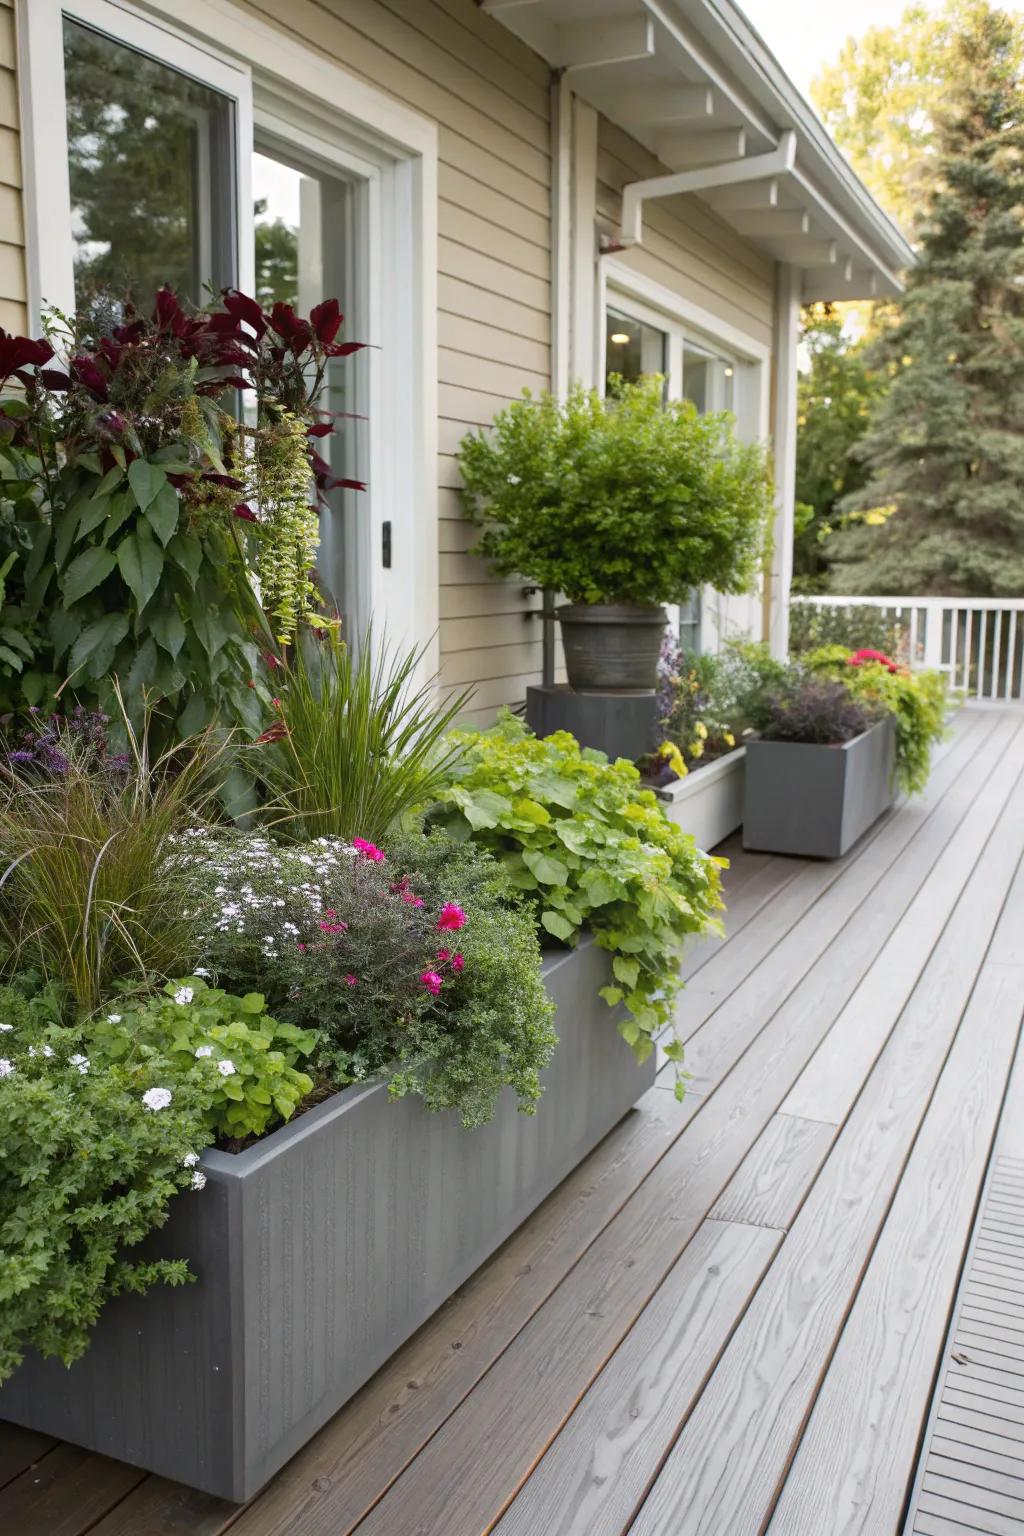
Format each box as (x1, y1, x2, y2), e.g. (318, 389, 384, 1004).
(801, 645, 949, 794)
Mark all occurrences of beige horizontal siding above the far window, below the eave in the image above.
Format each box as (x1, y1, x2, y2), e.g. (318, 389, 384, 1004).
(597, 117, 775, 344)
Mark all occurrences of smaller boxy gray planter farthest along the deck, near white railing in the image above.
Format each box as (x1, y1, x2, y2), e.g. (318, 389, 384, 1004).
(743, 719, 897, 859)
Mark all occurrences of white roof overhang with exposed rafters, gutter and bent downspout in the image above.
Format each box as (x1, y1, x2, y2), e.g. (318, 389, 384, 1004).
(482, 0, 913, 303)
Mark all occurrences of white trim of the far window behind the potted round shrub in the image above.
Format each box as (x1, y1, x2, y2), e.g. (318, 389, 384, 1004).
(596, 257, 772, 651)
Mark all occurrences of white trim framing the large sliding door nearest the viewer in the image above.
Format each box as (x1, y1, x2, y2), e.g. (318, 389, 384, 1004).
(15, 0, 439, 676)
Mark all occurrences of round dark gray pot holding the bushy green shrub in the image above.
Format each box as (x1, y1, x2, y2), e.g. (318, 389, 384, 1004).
(556, 602, 668, 691)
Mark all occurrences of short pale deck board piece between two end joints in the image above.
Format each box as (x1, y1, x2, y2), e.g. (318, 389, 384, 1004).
(711, 1115, 835, 1227)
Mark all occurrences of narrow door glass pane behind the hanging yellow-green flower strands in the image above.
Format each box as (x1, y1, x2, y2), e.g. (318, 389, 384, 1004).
(252, 141, 368, 636)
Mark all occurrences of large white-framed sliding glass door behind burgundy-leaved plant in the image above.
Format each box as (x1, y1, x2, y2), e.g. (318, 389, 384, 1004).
(18, 0, 438, 660)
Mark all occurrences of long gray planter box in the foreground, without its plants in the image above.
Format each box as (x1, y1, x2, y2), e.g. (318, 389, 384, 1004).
(0, 943, 656, 1501)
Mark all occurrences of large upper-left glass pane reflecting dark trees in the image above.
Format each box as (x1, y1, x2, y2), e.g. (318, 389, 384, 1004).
(64, 18, 236, 309)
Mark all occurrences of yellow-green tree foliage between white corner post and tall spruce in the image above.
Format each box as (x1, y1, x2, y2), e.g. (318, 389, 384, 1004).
(792, 304, 884, 593)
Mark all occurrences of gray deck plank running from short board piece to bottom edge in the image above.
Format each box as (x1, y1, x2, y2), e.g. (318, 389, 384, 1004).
(493, 1221, 781, 1536)
